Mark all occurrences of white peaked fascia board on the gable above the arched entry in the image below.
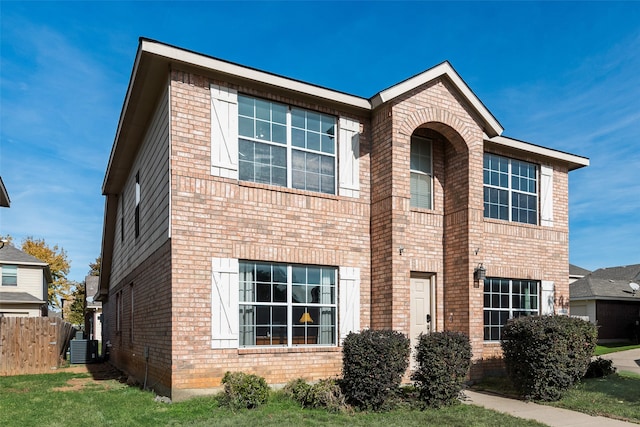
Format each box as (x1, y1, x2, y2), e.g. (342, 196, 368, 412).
(371, 62, 504, 135)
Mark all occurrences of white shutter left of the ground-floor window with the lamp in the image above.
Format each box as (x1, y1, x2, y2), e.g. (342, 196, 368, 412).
(211, 258, 239, 348)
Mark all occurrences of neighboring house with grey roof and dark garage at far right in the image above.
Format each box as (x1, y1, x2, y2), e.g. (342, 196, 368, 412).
(570, 264, 640, 342)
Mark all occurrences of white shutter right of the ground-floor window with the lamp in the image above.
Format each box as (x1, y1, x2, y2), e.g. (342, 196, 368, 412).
(339, 267, 360, 343)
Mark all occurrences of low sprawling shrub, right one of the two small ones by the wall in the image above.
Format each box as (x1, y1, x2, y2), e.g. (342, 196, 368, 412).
(283, 378, 347, 412)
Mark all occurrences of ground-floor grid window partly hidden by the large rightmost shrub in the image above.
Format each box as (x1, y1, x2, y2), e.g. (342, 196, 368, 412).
(484, 278, 540, 341)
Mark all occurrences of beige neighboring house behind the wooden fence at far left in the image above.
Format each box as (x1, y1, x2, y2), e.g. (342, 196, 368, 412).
(0, 244, 52, 317)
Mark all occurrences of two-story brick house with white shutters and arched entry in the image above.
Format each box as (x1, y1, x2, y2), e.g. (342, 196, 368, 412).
(100, 39, 589, 399)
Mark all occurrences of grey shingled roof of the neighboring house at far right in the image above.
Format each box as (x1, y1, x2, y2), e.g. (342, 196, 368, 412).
(569, 264, 640, 302)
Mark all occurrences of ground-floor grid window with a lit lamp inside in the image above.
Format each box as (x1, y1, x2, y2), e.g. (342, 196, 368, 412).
(239, 261, 337, 347)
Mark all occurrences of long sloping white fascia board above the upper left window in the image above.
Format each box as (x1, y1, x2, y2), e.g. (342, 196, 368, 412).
(141, 40, 371, 110)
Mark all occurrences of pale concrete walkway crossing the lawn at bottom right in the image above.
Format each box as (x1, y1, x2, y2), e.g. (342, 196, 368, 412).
(464, 390, 638, 427)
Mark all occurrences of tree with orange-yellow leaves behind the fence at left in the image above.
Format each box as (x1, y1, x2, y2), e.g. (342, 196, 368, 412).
(22, 236, 71, 309)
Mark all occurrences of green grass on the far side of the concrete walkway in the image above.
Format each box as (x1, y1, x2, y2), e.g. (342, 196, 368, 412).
(473, 371, 640, 423)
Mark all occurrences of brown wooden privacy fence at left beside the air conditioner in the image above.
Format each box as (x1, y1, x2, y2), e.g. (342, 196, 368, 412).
(0, 317, 75, 376)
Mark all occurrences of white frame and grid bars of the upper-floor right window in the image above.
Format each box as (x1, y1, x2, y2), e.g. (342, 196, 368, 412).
(482, 155, 541, 226)
